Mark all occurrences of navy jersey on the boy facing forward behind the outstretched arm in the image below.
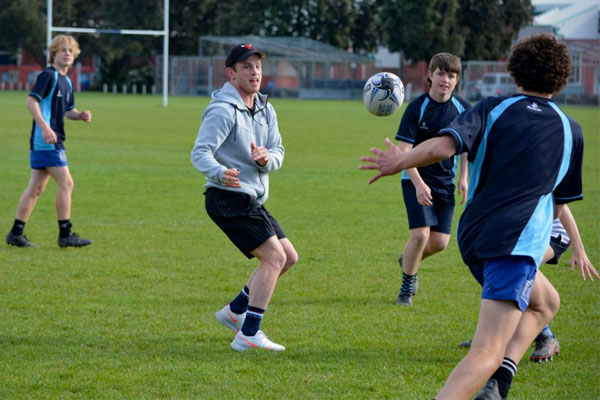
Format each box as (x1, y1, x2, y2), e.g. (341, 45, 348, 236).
(396, 93, 471, 193)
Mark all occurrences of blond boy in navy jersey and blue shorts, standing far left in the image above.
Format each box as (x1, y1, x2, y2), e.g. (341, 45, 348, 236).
(6, 35, 92, 247)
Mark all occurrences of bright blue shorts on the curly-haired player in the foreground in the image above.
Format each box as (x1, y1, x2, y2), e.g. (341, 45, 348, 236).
(469, 256, 537, 312)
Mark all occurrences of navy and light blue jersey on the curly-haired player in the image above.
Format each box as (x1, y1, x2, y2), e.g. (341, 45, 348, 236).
(438, 95, 583, 266)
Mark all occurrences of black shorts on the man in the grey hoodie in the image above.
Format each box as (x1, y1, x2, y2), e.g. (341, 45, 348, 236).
(204, 188, 286, 258)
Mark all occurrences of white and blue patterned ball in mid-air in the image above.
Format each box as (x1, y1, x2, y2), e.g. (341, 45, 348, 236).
(363, 72, 404, 117)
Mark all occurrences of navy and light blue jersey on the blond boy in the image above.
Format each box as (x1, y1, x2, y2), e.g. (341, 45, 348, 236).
(29, 67, 75, 150)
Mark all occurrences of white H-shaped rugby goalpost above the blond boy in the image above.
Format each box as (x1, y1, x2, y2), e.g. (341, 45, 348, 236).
(46, 0, 169, 107)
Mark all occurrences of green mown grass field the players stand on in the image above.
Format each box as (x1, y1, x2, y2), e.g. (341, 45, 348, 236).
(0, 92, 600, 400)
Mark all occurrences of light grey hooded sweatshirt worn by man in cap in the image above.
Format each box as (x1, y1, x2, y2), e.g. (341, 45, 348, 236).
(192, 82, 284, 204)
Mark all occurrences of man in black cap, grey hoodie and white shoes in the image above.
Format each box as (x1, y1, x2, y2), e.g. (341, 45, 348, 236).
(192, 44, 298, 351)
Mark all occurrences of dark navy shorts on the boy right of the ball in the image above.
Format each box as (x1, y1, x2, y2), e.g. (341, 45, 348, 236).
(402, 179, 455, 234)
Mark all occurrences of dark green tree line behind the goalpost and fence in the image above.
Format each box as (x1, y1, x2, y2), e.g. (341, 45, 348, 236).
(0, 0, 533, 82)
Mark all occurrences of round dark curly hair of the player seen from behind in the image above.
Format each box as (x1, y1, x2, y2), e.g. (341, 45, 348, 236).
(507, 33, 572, 94)
